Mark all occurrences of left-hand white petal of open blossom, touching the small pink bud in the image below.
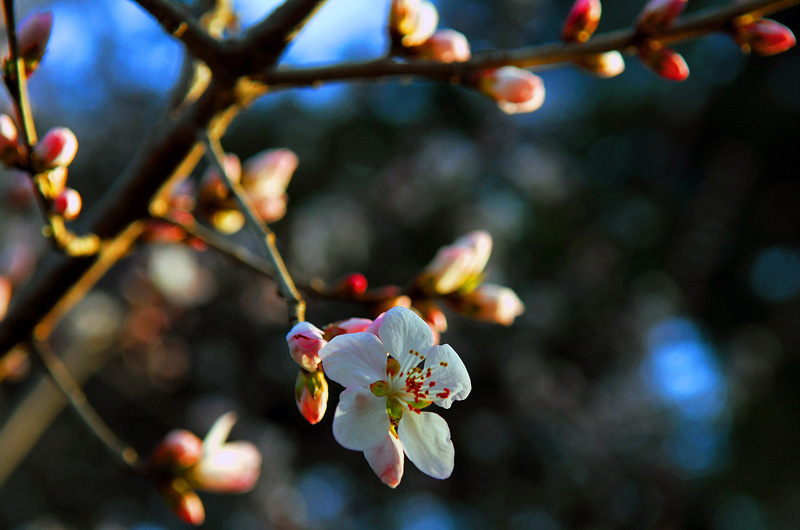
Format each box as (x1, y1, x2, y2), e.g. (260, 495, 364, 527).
(319, 332, 386, 388)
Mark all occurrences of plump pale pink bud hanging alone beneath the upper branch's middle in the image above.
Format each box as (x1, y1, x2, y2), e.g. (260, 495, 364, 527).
(477, 66, 544, 114)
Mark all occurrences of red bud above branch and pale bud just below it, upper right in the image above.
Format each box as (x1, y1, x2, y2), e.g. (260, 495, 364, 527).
(561, 0, 625, 78)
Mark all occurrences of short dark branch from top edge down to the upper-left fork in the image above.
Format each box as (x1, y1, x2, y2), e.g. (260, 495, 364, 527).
(129, 0, 222, 70)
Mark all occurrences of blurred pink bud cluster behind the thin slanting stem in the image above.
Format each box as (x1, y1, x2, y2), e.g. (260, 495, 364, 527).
(198, 149, 298, 234)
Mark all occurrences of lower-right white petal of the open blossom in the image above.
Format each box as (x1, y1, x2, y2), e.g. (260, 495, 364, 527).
(397, 411, 455, 479)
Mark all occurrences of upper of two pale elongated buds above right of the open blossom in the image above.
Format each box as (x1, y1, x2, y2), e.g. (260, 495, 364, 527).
(417, 230, 492, 294)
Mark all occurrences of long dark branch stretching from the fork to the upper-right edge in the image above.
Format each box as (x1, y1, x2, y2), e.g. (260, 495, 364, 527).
(255, 0, 800, 89)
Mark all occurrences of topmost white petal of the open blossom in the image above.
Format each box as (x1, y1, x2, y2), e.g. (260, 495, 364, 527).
(378, 307, 433, 370)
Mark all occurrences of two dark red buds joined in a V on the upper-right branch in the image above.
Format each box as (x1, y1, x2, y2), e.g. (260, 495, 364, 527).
(636, 0, 689, 81)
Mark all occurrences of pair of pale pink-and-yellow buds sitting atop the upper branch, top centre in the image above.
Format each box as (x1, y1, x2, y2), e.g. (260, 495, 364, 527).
(389, 0, 471, 63)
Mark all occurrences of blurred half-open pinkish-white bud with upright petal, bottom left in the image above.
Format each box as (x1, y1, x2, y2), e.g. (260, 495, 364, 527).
(191, 412, 261, 493)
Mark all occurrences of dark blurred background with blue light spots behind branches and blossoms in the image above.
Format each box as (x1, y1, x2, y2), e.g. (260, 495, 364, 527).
(0, 0, 800, 530)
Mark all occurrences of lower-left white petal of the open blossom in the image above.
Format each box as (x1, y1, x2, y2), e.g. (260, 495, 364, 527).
(333, 388, 390, 451)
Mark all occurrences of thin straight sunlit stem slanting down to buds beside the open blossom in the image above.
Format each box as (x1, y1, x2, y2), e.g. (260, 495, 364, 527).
(203, 135, 306, 324)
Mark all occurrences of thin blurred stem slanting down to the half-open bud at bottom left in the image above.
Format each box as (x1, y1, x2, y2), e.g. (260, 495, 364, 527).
(28, 340, 145, 472)
